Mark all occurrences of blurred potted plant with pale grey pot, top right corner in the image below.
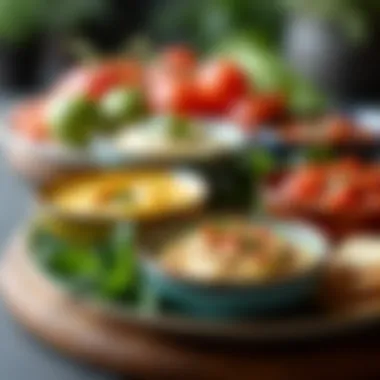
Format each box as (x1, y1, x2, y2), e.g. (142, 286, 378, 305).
(283, 0, 380, 101)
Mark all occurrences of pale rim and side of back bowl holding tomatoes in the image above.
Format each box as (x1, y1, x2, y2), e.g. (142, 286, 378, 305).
(0, 108, 247, 184)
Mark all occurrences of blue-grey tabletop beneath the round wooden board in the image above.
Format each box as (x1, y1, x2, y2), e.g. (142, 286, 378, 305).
(0, 154, 120, 380)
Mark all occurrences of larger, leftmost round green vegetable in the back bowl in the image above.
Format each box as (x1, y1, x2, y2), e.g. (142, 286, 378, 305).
(48, 96, 99, 146)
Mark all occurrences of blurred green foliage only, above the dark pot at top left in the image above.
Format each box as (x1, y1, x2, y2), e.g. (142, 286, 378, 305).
(0, 0, 107, 43)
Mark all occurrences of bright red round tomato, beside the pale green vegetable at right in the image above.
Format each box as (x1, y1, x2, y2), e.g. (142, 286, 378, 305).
(196, 61, 249, 114)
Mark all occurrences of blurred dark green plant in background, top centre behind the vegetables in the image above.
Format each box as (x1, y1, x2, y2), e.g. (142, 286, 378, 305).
(150, 0, 283, 50)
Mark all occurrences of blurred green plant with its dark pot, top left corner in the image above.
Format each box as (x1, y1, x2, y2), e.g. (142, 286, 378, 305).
(0, 0, 106, 90)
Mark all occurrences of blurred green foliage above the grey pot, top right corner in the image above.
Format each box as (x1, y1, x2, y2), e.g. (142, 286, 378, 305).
(282, 0, 380, 41)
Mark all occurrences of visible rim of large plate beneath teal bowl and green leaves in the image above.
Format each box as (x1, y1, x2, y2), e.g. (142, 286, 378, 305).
(22, 227, 380, 344)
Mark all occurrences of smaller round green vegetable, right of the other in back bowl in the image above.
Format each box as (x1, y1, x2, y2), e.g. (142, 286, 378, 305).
(100, 88, 146, 126)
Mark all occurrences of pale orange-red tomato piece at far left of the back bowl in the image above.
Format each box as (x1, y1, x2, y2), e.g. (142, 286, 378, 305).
(11, 100, 49, 141)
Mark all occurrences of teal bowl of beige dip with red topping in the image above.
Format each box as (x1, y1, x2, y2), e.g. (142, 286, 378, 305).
(141, 217, 328, 318)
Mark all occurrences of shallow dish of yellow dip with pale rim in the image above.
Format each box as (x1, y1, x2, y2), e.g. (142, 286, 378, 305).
(37, 170, 209, 229)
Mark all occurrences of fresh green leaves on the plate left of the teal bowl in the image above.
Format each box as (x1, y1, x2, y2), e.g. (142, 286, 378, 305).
(28, 222, 139, 301)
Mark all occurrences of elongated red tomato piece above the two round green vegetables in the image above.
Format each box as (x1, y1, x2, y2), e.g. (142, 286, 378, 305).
(55, 60, 143, 100)
